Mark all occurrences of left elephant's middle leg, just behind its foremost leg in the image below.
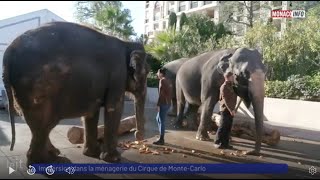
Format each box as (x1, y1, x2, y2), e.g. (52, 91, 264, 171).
(82, 109, 100, 157)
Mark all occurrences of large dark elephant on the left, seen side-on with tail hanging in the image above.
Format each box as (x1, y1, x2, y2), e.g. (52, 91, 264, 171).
(3, 22, 150, 165)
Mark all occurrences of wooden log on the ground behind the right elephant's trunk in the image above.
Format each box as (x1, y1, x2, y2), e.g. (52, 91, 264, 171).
(212, 114, 280, 146)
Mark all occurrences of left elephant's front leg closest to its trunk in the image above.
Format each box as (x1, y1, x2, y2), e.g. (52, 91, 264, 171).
(100, 91, 124, 162)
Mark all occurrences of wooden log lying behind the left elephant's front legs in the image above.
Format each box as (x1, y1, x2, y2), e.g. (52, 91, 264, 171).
(67, 116, 136, 144)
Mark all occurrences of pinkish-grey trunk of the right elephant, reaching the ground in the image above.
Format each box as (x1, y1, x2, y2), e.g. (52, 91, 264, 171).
(249, 70, 265, 152)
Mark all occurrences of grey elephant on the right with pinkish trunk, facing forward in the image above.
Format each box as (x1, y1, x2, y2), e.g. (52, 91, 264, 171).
(176, 48, 265, 154)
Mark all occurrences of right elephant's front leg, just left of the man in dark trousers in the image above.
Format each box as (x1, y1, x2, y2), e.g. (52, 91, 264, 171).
(196, 95, 219, 141)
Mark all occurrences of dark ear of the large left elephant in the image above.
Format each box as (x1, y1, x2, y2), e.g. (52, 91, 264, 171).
(129, 50, 147, 81)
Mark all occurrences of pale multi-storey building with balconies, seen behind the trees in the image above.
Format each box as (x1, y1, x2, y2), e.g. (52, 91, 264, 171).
(144, 1, 315, 39)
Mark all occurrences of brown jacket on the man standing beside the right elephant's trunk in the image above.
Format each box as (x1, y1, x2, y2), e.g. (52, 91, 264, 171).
(220, 81, 237, 113)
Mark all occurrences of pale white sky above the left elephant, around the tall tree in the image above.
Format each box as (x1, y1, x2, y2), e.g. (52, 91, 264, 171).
(0, 1, 144, 35)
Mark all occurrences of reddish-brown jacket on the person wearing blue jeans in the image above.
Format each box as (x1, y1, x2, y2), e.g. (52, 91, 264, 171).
(157, 78, 172, 106)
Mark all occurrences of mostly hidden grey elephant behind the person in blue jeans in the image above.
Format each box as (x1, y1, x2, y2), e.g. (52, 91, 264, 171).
(163, 58, 189, 116)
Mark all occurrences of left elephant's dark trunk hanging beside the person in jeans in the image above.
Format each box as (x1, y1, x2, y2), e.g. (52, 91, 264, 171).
(134, 86, 147, 141)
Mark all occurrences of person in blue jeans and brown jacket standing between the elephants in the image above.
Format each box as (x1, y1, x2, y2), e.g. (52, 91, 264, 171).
(153, 68, 172, 145)
